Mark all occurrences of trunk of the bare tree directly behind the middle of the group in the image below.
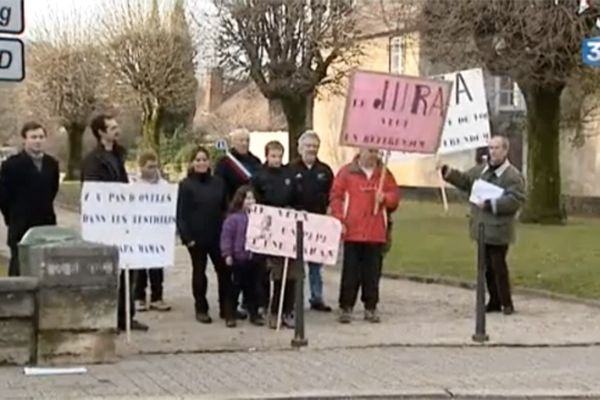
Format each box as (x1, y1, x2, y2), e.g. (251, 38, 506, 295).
(281, 95, 313, 160)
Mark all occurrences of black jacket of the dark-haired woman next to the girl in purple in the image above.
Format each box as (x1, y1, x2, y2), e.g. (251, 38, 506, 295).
(177, 172, 227, 246)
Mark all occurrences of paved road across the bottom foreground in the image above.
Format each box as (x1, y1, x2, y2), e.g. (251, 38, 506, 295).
(0, 347, 600, 400)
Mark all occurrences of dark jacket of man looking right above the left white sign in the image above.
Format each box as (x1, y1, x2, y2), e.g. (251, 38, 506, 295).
(81, 145, 129, 183)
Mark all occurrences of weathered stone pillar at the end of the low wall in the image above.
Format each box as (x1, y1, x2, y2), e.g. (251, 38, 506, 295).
(20, 240, 119, 364)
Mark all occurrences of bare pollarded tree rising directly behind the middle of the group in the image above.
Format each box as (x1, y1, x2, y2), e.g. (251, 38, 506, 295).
(214, 0, 360, 157)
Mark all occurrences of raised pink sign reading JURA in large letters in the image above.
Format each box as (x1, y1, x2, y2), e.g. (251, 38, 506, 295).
(340, 71, 451, 154)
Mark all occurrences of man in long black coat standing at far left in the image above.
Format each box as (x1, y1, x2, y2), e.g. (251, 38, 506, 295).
(0, 122, 59, 276)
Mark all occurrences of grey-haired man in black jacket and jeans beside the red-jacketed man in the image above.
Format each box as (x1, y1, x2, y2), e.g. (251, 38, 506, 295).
(289, 130, 333, 312)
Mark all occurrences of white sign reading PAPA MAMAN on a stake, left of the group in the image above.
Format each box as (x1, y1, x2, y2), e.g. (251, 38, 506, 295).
(81, 182, 177, 269)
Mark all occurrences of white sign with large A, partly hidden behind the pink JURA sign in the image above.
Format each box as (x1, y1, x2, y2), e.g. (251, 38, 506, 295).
(390, 68, 491, 160)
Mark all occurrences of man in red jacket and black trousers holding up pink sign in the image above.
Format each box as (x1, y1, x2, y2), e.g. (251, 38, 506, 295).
(330, 149, 400, 324)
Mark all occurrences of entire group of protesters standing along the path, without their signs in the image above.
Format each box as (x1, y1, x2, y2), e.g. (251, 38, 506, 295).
(0, 114, 524, 331)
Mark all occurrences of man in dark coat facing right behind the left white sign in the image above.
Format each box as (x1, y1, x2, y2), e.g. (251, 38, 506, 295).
(81, 114, 148, 331)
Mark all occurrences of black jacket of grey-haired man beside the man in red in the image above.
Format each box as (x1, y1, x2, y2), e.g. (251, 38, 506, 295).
(289, 159, 333, 214)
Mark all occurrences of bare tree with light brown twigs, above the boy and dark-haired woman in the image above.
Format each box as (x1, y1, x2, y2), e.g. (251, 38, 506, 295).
(103, 0, 198, 153)
